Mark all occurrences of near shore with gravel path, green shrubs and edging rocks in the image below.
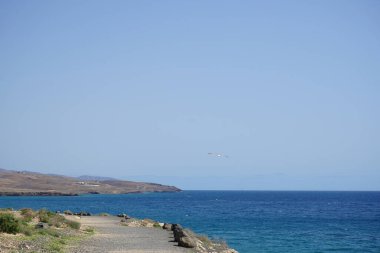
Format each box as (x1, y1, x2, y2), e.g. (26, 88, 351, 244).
(0, 208, 238, 253)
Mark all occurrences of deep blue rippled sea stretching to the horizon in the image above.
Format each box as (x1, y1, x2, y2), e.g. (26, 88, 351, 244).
(0, 191, 380, 253)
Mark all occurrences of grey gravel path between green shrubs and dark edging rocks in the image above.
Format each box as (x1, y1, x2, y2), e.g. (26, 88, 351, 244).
(68, 216, 192, 253)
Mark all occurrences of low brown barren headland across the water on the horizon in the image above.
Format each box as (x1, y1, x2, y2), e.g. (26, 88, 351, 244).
(0, 169, 181, 196)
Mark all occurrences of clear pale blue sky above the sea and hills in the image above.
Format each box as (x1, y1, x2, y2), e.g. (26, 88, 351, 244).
(0, 0, 380, 190)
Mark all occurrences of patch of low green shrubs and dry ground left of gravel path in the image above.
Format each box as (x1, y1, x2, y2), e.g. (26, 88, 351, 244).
(0, 208, 84, 252)
